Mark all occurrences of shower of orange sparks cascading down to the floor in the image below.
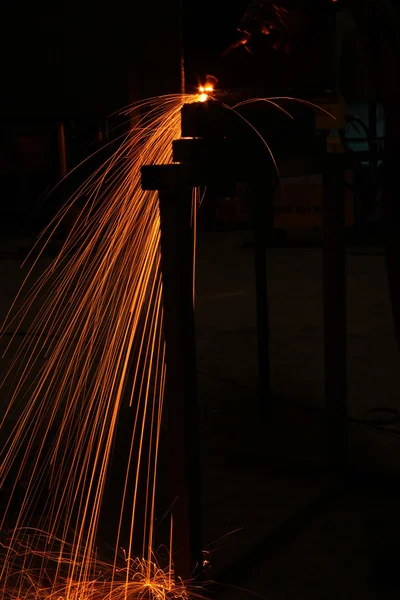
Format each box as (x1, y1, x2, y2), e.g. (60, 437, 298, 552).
(0, 94, 205, 600)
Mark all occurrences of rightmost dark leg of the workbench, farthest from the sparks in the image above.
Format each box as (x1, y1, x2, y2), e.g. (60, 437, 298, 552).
(323, 155, 347, 466)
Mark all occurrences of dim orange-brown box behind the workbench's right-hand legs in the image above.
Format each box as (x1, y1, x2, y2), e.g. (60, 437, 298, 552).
(274, 172, 354, 229)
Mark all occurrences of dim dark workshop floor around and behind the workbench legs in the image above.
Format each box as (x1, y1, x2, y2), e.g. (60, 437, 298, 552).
(0, 232, 400, 600)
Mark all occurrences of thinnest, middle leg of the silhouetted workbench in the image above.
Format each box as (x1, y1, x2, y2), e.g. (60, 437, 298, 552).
(248, 173, 272, 416)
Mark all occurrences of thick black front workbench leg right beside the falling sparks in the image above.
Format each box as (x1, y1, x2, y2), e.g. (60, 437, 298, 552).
(159, 188, 202, 579)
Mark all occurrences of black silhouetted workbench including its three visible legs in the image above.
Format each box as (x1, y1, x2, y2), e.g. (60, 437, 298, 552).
(142, 101, 347, 577)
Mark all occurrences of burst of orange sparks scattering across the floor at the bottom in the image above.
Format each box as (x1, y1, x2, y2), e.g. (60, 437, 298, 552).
(2, 530, 201, 600)
